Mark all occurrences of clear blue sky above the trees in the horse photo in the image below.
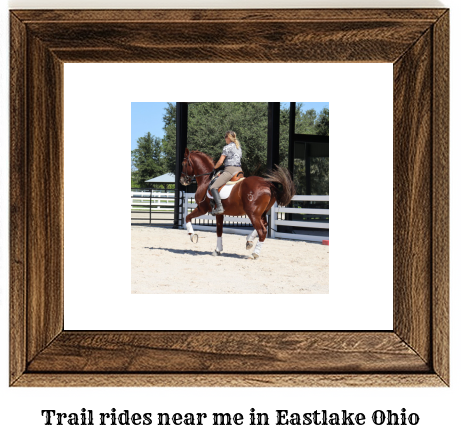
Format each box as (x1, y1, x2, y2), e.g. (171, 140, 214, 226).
(131, 102, 329, 150)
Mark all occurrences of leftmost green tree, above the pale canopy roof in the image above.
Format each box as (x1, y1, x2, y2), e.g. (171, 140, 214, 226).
(131, 132, 165, 188)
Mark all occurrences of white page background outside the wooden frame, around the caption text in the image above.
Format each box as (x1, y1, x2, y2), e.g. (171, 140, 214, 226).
(0, 1, 461, 436)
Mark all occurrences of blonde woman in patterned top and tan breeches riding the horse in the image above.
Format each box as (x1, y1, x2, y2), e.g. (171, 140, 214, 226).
(210, 130, 242, 215)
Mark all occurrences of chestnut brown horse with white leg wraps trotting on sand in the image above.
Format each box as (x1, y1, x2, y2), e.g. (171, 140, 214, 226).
(180, 148, 295, 259)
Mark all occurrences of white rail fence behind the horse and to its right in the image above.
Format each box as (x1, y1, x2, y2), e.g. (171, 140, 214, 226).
(183, 194, 330, 242)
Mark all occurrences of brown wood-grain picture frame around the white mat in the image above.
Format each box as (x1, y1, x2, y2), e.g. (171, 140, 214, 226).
(10, 9, 449, 386)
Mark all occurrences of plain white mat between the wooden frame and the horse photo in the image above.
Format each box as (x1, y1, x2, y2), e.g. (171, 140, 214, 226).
(64, 64, 393, 330)
